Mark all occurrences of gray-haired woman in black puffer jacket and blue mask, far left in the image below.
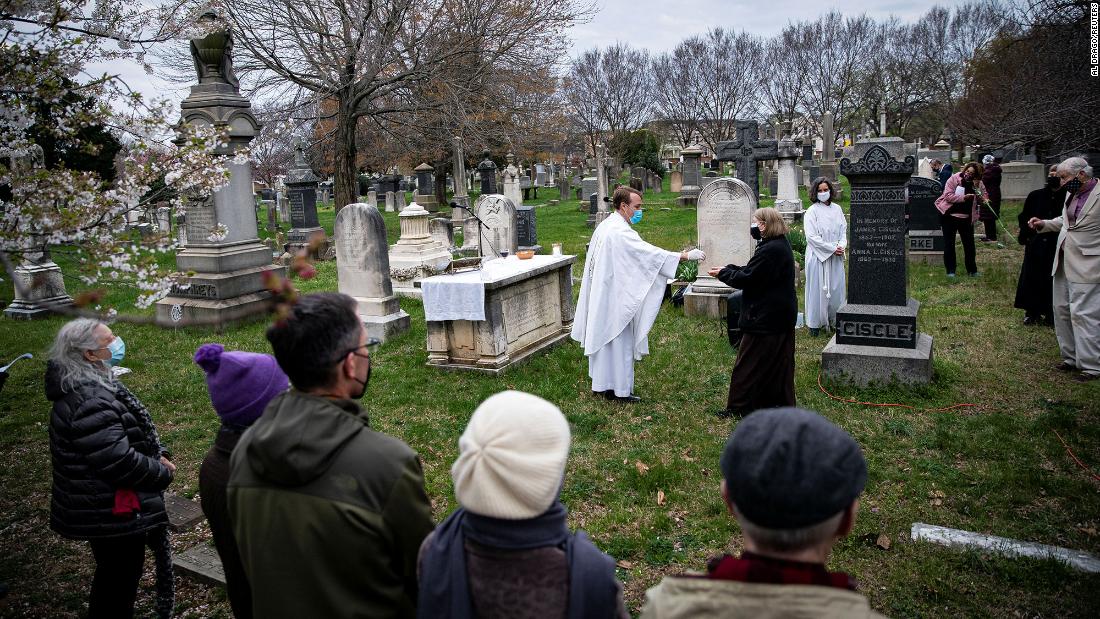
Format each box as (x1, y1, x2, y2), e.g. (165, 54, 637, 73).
(45, 318, 176, 617)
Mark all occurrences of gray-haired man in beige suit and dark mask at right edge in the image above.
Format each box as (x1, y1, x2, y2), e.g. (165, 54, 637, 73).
(1027, 157, 1100, 383)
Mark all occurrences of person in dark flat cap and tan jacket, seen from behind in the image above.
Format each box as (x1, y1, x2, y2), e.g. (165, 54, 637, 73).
(641, 408, 882, 619)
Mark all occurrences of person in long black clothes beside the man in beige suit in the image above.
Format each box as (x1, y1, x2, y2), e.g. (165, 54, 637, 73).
(1013, 165, 1066, 324)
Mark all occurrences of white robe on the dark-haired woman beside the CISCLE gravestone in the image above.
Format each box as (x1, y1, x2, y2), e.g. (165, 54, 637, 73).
(803, 202, 848, 329)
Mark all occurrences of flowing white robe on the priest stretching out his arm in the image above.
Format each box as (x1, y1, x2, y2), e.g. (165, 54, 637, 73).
(572, 212, 680, 397)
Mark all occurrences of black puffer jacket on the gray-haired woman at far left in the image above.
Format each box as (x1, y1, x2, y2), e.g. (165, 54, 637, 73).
(46, 363, 172, 540)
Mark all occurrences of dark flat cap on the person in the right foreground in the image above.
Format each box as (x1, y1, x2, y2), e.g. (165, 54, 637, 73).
(719, 408, 867, 529)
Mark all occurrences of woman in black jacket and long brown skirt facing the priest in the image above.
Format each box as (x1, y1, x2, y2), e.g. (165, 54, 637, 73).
(708, 208, 799, 417)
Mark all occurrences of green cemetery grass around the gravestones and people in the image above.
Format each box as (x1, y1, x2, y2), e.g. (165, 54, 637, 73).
(0, 191, 1100, 617)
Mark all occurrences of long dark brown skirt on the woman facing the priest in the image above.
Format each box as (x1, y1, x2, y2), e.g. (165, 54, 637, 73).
(726, 329, 795, 414)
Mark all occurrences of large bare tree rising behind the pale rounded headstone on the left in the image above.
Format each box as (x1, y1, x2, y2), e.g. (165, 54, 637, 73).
(206, 0, 590, 211)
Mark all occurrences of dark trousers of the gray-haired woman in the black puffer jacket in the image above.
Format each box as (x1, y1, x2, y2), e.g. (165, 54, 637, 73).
(88, 532, 145, 619)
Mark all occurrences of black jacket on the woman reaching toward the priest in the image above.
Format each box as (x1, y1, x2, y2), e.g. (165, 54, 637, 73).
(718, 235, 799, 335)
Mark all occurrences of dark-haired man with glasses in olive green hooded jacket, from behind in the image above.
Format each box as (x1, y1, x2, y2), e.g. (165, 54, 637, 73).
(229, 292, 433, 619)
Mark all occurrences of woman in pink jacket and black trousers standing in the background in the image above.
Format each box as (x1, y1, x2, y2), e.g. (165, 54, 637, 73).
(936, 162, 989, 277)
